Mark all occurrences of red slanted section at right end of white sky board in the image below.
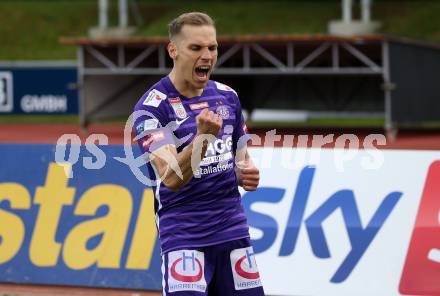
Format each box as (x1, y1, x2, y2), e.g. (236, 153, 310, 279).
(399, 161, 440, 295)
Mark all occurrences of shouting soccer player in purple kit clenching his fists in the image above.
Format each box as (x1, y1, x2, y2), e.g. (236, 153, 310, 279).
(134, 12, 264, 296)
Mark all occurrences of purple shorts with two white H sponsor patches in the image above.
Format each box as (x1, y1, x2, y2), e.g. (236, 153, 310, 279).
(162, 238, 264, 296)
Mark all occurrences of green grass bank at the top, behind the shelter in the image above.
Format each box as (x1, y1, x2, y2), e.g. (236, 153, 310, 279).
(0, 0, 440, 60)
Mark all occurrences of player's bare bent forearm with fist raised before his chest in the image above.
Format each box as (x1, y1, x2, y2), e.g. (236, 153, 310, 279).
(150, 109, 223, 191)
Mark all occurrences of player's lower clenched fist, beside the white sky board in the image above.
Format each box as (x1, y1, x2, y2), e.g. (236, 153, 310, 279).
(235, 146, 260, 191)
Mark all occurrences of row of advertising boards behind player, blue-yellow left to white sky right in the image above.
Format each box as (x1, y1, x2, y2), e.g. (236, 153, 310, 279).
(0, 144, 440, 296)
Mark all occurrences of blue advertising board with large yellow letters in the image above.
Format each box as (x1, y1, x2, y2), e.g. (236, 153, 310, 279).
(0, 144, 161, 290)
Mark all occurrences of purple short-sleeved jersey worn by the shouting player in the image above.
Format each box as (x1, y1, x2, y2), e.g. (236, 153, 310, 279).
(134, 76, 249, 253)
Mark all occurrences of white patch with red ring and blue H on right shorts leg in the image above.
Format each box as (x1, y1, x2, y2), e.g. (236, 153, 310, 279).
(230, 247, 261, 290)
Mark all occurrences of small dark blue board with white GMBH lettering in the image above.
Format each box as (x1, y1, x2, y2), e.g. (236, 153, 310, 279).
(0, 64, 78, 114)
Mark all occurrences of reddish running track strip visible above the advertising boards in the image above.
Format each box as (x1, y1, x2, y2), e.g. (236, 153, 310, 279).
(0, 124, 440, 150)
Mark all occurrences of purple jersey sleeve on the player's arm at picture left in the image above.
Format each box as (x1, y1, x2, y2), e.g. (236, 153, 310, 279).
(133, 97, 175, 153)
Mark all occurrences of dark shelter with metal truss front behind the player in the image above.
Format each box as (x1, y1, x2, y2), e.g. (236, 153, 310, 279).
(61, 0, 440, 131)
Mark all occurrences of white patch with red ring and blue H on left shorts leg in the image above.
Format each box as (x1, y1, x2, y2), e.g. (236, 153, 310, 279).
(168, 250, 206, 293)
